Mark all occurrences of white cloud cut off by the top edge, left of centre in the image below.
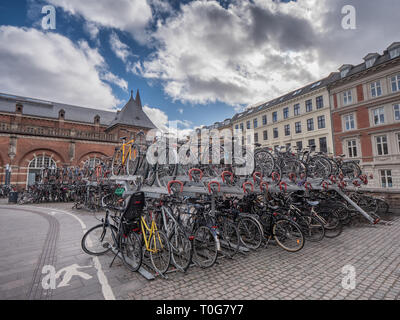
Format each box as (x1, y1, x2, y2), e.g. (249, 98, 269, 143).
(47, 0, 152, 42)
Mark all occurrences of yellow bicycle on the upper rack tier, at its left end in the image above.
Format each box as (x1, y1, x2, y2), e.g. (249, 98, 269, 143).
(111, 137, 140, 176)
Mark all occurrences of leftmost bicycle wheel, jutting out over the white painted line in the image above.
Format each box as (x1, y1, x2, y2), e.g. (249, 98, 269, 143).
(81, 224, 117, 256)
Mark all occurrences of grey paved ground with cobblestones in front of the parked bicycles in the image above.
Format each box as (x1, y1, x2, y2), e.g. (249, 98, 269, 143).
(0, 203, 400, 300)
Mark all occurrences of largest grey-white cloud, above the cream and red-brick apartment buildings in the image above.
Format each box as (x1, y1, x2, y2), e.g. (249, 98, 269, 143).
(130, 0, 400, 109)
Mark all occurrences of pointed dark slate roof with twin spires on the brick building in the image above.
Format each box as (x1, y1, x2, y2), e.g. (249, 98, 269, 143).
(108, 90, 156, 129)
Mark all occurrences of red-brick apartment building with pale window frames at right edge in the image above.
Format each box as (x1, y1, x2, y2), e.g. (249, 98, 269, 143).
(328, 42, 400, 190)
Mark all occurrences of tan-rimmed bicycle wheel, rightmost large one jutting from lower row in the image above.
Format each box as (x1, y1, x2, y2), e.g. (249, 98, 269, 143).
(272, 219, 305, 252)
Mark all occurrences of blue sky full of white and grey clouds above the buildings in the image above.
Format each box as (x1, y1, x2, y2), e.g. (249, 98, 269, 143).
(0, 0, 400, 129)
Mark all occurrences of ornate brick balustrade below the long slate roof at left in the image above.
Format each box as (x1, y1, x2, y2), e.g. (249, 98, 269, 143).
(0, 122, 118, 142)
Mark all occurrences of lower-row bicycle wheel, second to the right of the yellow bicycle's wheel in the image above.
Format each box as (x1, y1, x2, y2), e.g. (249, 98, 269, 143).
(193, 226, 218, 268)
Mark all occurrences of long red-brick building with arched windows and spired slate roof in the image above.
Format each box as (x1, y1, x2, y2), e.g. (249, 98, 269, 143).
(0, 91, 155, 188)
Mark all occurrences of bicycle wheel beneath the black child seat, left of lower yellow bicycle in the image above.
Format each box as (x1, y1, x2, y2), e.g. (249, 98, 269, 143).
(119, 232, 143, 272)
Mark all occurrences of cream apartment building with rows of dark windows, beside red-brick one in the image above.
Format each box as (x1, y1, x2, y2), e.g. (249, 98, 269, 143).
(232, 76, 333, 153)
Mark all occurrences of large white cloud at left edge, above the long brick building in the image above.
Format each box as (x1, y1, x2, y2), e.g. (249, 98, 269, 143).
(0, 26, 123, 109)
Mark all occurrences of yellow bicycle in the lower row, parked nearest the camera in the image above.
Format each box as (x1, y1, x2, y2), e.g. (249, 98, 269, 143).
(140, 212, 171, 275)
